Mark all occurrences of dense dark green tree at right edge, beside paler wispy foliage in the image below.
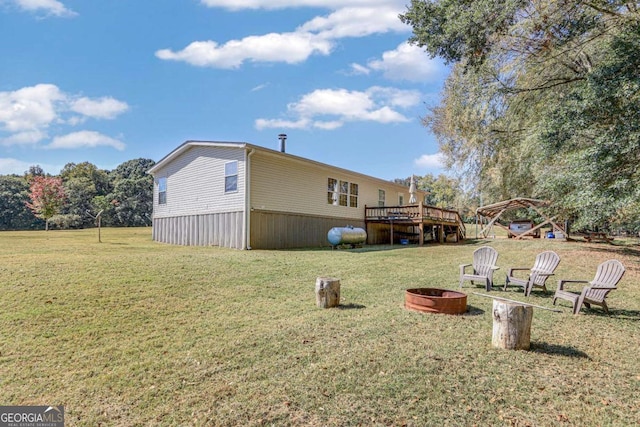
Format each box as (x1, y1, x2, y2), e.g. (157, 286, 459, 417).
(540, 24, 640, 229)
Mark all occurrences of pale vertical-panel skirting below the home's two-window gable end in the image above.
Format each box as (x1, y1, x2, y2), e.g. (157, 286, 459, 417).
(153, 211, 244, 249)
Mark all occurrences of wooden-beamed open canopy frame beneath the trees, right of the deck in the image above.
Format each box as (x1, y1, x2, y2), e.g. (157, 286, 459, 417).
(476, 197, 565, 239)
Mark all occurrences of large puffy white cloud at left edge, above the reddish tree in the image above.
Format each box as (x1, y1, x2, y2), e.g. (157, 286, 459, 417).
(0, 84, 129, 149)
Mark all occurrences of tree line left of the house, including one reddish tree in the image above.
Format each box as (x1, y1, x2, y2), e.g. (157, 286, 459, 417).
(0, 158, 155, 230)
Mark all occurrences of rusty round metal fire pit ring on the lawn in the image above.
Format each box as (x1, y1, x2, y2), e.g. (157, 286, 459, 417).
(404, 288, 467, 314)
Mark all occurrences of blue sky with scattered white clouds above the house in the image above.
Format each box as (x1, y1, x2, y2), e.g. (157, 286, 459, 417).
(0, 0, 448, 179)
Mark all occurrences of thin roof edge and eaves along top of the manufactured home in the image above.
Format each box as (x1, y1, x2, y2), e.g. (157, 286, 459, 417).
(147, 141, 426, 193)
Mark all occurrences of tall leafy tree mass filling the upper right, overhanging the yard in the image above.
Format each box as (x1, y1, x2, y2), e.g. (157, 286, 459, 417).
(400, 0, 640, 231)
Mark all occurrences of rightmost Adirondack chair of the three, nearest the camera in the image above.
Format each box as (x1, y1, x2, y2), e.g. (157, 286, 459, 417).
(553, 259, 625, 314)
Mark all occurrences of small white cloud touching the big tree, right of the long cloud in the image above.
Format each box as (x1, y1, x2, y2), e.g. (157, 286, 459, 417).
(367, 43, 444, 82)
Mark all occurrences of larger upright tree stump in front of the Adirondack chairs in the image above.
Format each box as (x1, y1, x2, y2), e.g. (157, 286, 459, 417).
(491, 300, 533, 350)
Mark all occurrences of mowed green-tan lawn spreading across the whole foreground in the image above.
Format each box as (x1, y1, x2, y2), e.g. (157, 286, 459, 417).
(0, 229, 640, 426)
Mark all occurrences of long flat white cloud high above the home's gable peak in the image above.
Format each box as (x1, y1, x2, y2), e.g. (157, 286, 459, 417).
(156, 33, 333, 69)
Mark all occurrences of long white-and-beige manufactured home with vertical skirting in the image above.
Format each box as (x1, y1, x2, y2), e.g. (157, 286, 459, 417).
(149, 141, 460, 249)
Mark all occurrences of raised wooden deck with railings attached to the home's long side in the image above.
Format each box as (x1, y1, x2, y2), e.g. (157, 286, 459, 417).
(365, 204, 466, 245)
